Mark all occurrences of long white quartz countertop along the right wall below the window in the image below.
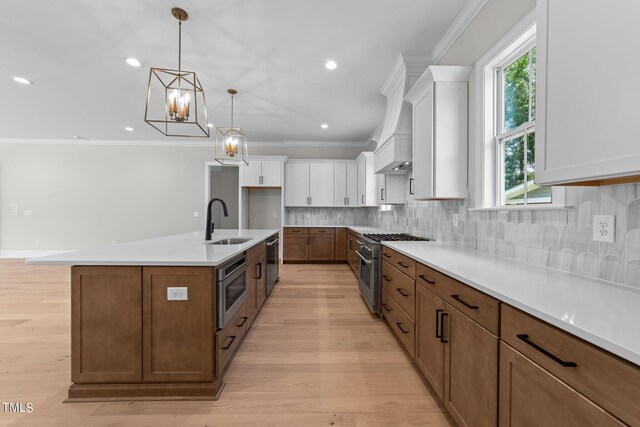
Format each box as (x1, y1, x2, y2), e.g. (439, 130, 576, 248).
(383, 242, 640, 365)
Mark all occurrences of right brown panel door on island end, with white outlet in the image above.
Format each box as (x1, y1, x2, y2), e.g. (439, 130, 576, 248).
(143, 267, 215, 382)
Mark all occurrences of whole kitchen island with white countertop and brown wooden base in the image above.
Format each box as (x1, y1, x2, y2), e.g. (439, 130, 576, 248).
(27, 230, 278, 402)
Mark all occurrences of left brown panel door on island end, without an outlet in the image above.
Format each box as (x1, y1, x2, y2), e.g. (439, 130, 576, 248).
(71, 267, 142, 383)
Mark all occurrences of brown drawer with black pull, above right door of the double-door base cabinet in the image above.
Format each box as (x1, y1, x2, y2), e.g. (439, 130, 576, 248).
(436, 275, 500, 336)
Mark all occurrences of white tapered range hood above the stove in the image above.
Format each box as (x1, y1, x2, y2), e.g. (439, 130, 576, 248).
(374, 53, 431, 173)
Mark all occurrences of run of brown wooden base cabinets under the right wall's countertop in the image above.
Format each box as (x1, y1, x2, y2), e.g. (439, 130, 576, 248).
(382, 246, 640, 427)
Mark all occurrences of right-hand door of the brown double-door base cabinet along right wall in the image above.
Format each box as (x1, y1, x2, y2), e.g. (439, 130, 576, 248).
(441, 303, 500, 427)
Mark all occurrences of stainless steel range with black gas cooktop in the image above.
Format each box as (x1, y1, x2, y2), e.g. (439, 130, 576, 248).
(356, 233, 433, 316)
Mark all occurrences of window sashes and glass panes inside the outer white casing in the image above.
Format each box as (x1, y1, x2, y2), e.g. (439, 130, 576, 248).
(495, 46, 551, 206)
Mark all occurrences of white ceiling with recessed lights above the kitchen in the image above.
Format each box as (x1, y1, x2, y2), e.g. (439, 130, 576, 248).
(0, 0, 466, 142)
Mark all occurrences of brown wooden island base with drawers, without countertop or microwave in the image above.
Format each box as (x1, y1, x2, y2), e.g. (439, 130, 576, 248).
(68, 236, 266, 401)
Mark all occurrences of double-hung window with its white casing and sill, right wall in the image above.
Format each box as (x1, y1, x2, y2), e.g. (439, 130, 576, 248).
(471, 11, 565, 210)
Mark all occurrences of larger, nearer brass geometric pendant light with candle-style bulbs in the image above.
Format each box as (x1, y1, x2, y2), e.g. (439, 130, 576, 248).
(144, 7, 210, 138)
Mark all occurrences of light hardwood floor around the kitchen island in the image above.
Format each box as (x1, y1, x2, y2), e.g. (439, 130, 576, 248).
(0, 260, 453, 426)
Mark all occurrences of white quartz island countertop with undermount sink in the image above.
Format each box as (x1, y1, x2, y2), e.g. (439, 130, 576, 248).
(26, 230, 279, 267)
